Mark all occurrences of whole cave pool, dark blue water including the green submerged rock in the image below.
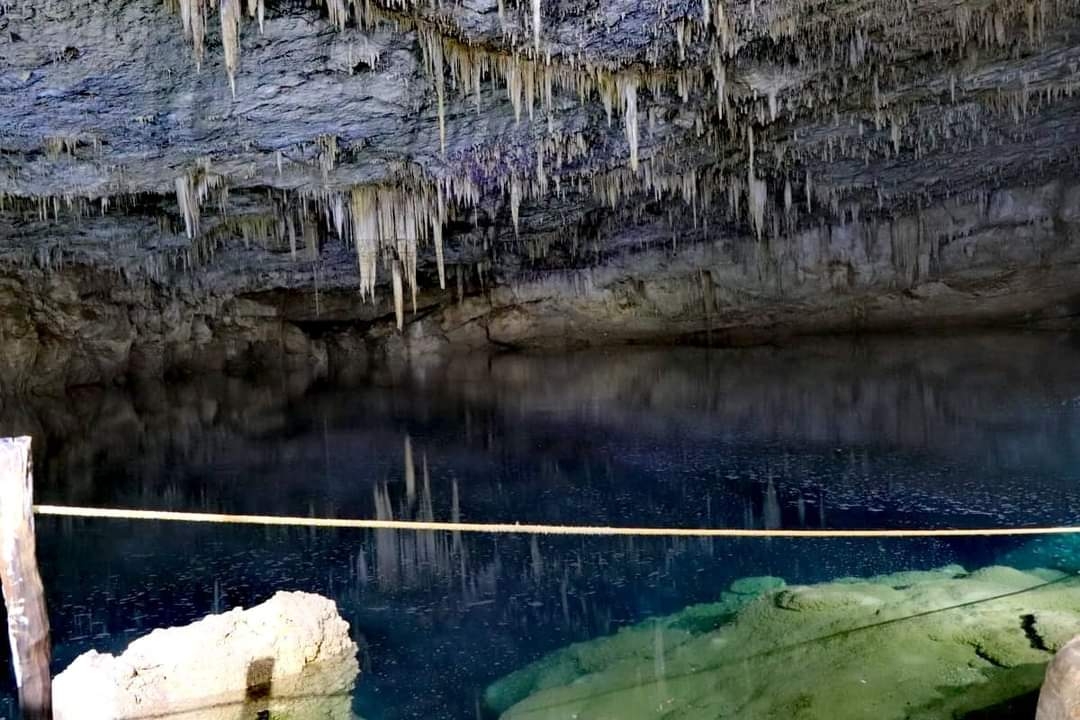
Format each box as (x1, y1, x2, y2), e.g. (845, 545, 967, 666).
(0, 335, 1080, 720)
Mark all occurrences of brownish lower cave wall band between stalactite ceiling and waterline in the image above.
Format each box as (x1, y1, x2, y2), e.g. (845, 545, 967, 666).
(0, 181, 1080, 392)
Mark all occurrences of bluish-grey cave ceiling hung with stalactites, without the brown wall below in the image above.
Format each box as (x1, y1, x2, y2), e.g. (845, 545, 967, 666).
(0, 0, 1080, 324)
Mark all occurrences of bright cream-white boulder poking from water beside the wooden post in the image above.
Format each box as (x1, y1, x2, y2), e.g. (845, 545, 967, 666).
(53, 593, 360, 720)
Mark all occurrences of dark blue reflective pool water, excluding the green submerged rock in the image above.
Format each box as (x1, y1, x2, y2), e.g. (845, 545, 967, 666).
(0, 336, 1080, 720)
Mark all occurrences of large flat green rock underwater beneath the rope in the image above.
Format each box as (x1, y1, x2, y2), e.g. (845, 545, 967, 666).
(485, 566, 1080, 720)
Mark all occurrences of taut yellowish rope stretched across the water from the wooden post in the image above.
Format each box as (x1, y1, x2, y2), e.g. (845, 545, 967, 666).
(25, 505, 1080, 538)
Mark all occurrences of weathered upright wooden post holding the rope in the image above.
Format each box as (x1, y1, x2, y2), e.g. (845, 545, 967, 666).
(0, 437, 53, 720)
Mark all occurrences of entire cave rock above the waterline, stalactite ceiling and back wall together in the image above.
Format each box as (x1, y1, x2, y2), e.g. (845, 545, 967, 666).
(0, 0, 1080, 392)
